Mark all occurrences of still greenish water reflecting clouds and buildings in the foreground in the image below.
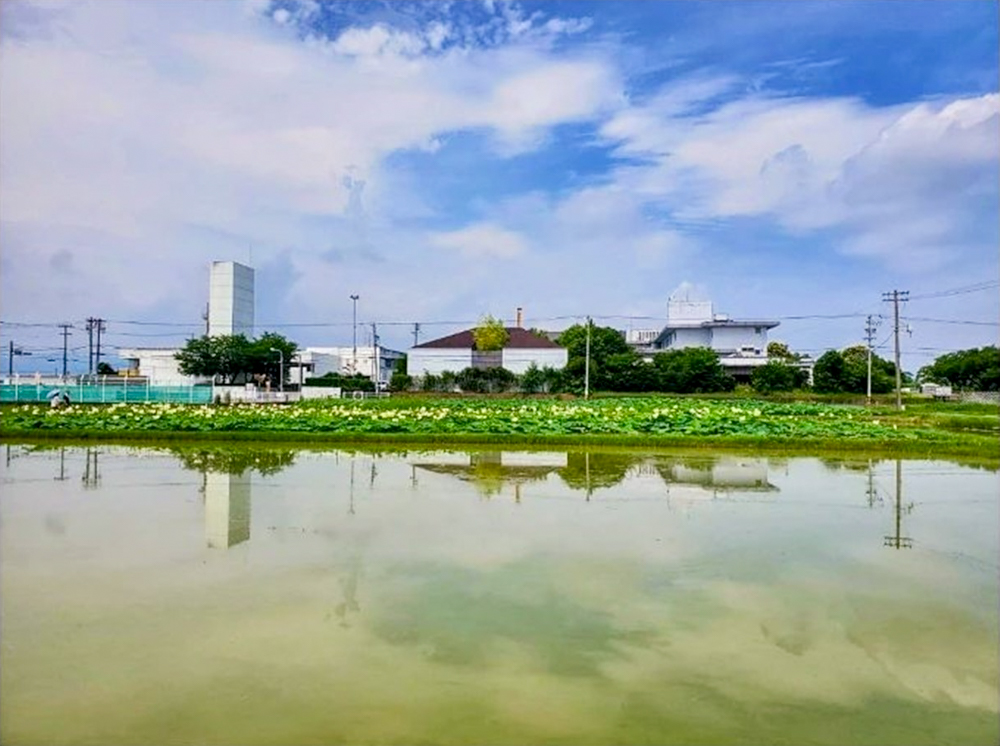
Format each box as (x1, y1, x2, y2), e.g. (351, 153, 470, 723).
(0, 445, 1000, 746)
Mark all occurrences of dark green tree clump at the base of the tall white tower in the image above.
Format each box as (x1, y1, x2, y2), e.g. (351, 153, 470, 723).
(175, 332, 298, 385)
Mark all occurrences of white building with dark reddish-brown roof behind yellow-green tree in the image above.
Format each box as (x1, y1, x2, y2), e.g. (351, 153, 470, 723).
(406, 326, 567, 376)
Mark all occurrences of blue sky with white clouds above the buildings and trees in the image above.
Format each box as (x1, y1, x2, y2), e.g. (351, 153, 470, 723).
(0, 0, 1000, 374)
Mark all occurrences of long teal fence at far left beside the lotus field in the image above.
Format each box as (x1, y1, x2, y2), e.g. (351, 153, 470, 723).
(0, 378, 212, 404)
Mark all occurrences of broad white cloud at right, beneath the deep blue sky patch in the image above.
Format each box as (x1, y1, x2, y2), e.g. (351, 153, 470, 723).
(602, 78, 1000, 269)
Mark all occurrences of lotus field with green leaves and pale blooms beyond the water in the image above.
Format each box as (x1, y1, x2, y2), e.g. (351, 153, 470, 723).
(0, 397, 940, 441)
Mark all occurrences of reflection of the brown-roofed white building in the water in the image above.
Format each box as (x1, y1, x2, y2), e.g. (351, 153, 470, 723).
(411, 451, 567, 501)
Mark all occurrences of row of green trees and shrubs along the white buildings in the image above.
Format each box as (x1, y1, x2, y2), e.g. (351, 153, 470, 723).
(176, 320, 1000, 394)
